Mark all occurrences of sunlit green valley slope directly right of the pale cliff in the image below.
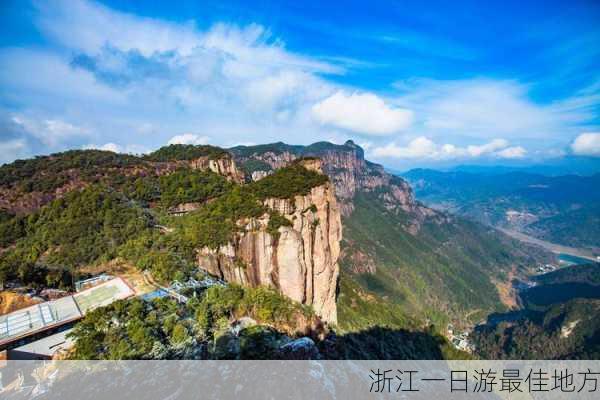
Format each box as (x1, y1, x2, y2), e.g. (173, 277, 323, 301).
(342, 189, 536, 326)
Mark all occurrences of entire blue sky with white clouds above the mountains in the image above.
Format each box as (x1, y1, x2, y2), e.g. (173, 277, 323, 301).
(0, 0, 600, 168)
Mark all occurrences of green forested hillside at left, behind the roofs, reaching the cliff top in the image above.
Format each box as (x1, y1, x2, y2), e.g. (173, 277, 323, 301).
(0, 146, 327, 288)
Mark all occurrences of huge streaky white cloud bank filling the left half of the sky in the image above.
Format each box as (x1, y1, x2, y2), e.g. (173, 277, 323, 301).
(0, 0, 348, 163)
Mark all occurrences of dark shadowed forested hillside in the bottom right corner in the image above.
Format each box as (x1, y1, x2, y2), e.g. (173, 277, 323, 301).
(473, 264, 600, 360)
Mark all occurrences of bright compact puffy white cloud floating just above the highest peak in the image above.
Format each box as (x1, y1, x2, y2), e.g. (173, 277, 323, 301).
(312, 91, 413, 135)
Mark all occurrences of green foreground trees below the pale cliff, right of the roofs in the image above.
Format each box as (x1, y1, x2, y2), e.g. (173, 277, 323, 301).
(70, 285, 323, 360)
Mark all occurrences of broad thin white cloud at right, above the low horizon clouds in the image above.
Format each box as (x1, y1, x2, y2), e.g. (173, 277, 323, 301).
(395, 79, 598, 140)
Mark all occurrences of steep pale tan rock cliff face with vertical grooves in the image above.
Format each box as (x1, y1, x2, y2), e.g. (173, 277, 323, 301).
(197, 161, 342, 323)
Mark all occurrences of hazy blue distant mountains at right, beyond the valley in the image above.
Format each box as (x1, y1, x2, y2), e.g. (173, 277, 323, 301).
(403, 168, 600, 248)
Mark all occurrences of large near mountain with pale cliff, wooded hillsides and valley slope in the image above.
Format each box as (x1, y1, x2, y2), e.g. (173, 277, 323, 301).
(0, 141, 553, 358)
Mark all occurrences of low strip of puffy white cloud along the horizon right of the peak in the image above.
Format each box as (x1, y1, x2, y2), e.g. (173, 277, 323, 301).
(371, 136, 526, 161)
